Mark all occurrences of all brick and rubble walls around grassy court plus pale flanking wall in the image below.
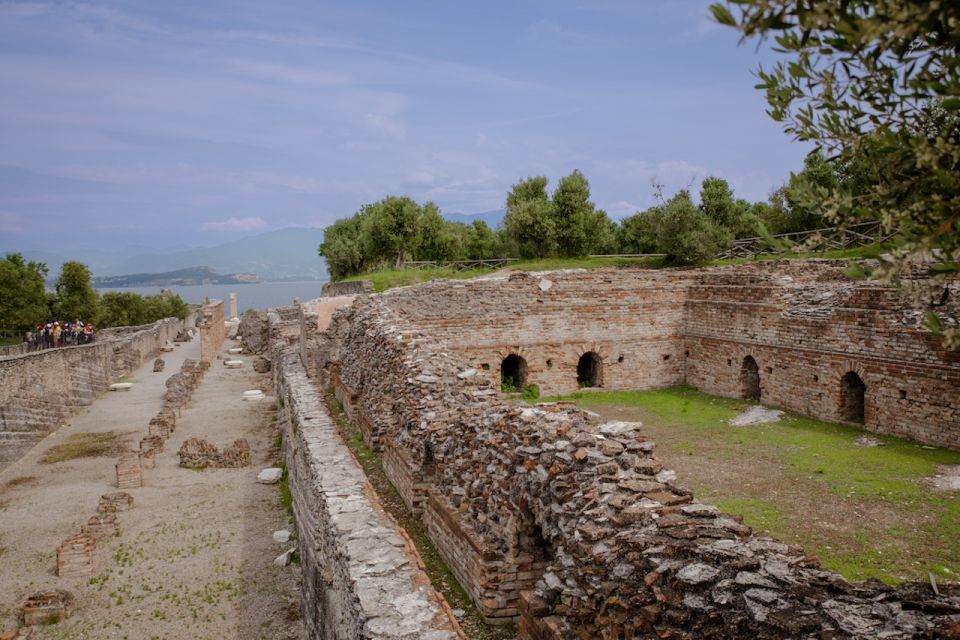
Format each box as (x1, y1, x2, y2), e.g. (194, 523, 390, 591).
(264, 261, 960, 640)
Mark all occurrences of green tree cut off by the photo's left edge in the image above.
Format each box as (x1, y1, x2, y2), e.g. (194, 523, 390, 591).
(0, 253, 47, 337)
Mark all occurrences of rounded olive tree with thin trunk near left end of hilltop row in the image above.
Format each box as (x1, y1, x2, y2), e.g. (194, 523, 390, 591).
(362, 196, 421, 269)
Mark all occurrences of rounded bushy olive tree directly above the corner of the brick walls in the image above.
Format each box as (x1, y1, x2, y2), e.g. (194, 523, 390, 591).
(655, 190, 733, 264)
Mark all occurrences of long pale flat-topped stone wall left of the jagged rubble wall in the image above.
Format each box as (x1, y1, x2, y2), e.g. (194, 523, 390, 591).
(267, 309, 462, 640)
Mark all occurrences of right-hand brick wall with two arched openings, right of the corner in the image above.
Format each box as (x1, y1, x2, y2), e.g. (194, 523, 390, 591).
(684, 262, 960, 448)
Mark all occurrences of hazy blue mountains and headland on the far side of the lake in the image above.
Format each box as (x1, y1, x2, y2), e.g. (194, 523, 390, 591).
(15, 227, 327, 282)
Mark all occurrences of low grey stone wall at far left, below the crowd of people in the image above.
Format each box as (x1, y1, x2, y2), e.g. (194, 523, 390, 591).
(0, 318, 184, 470)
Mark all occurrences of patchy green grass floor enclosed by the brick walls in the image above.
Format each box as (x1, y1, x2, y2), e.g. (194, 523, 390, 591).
(544, 387, 960, 583)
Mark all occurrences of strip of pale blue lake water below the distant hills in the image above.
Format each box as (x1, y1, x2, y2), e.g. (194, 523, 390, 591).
(98, 281, 323, 315)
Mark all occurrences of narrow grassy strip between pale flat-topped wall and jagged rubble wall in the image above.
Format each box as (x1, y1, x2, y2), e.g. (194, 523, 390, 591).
(324, 389, 517, 640)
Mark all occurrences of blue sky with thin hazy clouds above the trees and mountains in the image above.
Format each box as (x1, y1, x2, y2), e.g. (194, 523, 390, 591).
(0, 0, 805, 251)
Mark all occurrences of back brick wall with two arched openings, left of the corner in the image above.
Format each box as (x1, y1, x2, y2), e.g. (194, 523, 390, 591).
(382, 269, 690, 394)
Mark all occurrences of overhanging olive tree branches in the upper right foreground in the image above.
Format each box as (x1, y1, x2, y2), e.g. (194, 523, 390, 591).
(711, 0, 960, 345)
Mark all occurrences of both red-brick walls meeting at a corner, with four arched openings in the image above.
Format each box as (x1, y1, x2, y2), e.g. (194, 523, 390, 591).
(376, 260, 960, 448)
